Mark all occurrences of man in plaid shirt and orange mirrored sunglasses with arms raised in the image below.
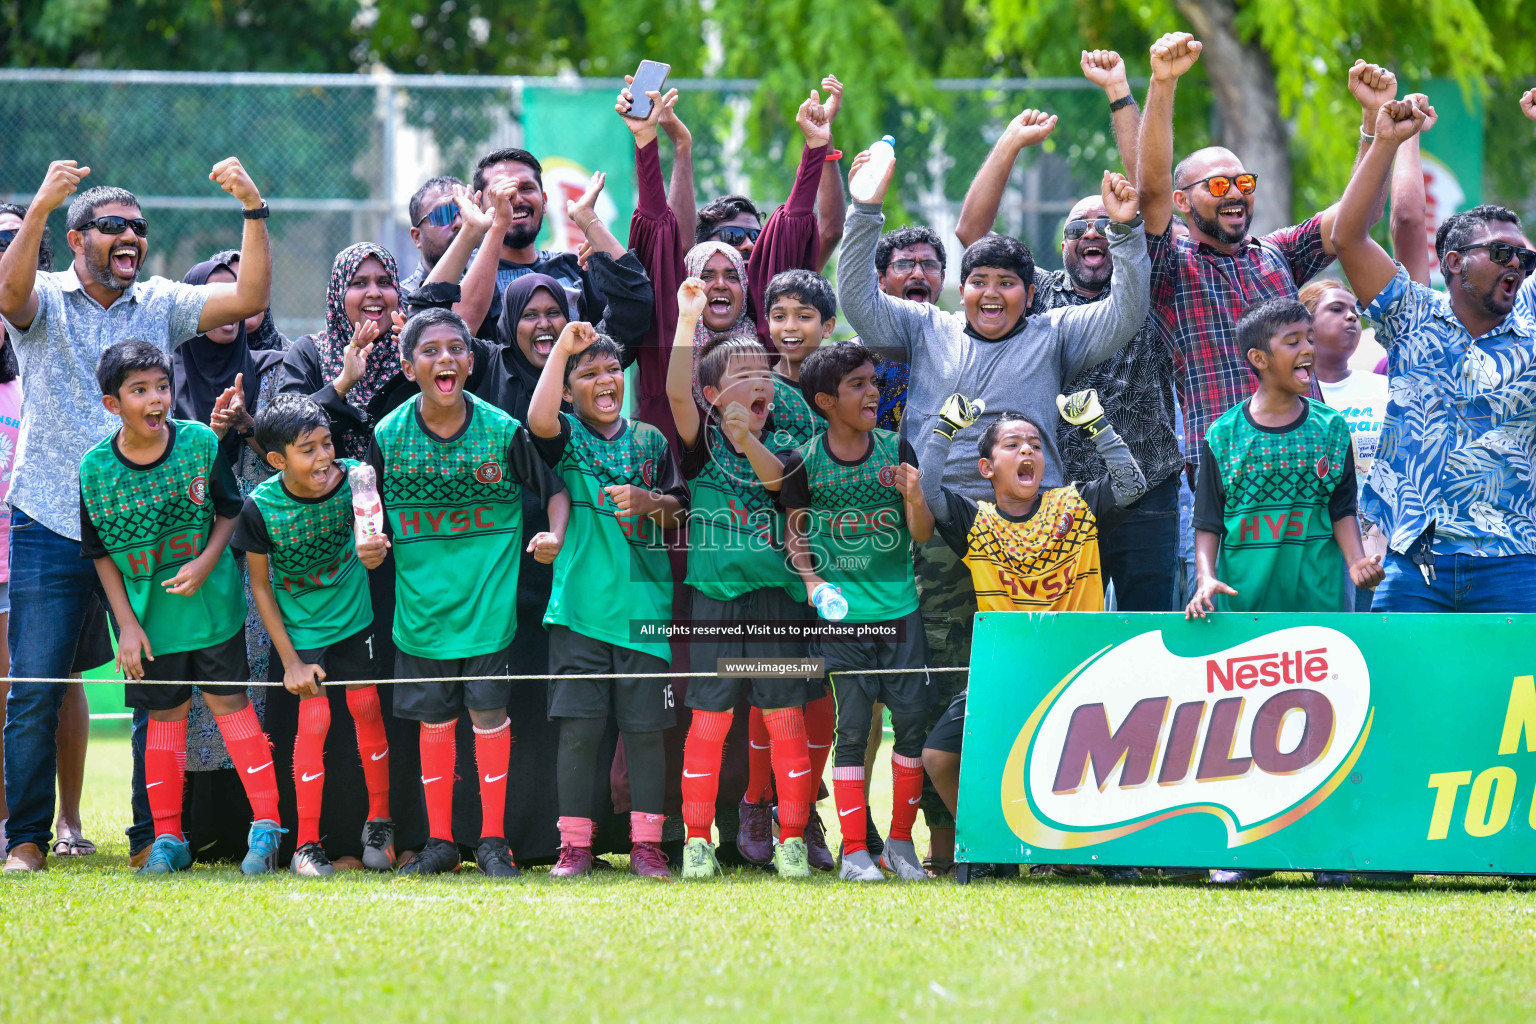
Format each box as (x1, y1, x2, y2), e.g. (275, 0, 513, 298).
(1137, 32, 1398, 475)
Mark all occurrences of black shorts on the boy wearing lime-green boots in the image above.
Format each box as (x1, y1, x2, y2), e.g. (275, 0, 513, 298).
(684, 586, 826, 711)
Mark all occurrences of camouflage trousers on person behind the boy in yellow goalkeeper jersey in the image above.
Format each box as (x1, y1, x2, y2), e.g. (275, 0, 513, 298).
(914, 536, 975, 829)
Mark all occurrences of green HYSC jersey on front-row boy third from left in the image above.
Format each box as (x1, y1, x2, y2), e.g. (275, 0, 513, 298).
(369, 395, 541, 660)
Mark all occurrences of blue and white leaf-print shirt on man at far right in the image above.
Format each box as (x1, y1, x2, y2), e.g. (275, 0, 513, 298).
(1361, 267, 1536, 557)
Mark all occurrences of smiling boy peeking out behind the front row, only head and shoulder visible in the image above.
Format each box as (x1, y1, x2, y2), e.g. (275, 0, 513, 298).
(763, 270, 837, 445)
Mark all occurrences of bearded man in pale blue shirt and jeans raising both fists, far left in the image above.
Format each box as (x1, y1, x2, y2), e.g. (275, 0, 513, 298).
(0, 157, 272, 870)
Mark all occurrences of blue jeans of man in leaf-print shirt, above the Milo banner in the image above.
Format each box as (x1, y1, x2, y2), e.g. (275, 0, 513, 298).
(1376, 551, 1536, 607)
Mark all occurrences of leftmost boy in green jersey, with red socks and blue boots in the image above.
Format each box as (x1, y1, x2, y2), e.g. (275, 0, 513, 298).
(80, 341, 283, 875)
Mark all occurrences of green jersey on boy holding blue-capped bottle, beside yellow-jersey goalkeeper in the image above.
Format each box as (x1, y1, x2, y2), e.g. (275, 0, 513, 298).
(779, 428, 917, 622)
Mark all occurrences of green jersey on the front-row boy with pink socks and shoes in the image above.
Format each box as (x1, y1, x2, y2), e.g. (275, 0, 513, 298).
(533, 413, 688, 663)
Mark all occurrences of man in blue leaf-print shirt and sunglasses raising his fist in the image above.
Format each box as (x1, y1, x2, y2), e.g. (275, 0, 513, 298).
(1333, 101, 1536, 613)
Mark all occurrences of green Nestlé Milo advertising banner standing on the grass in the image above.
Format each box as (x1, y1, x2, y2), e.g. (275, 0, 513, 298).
(957, 613, 1536, 874)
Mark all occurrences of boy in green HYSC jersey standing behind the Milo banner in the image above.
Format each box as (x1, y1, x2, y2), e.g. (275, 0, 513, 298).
(1184, 291, 1382, 619)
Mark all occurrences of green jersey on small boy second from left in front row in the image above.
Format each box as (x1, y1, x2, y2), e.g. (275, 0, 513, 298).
(233, 459, 373, 651)
